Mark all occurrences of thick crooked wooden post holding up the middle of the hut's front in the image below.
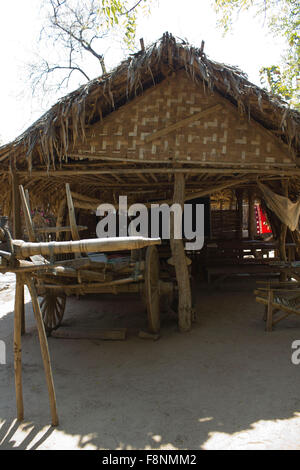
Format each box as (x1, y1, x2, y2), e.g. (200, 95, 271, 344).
(170, 173, 192, 332)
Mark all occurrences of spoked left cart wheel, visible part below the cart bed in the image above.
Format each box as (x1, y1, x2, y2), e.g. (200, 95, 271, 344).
(40, 292, 66, 333)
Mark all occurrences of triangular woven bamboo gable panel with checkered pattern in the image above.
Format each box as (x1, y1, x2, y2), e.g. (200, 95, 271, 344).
(76, 72, 292, 166)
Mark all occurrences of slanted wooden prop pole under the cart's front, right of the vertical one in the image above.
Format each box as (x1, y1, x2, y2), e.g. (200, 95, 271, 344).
(26, 276, 58, 426)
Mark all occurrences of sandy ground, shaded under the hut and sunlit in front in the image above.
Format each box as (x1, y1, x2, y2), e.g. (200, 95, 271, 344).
(0, 275, 300, 449)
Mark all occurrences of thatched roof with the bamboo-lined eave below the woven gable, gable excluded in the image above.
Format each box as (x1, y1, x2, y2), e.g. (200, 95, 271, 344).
(0, 33, 300, 220)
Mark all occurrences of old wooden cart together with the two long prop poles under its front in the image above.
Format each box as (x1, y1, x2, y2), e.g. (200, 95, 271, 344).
(0, 209, 172, 426)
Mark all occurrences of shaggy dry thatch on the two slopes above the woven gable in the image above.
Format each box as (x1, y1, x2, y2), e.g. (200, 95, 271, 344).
(0, 33, 300, 170)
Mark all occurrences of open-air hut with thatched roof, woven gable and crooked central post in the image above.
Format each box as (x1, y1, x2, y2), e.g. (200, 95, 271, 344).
(0, 33, 300, 330)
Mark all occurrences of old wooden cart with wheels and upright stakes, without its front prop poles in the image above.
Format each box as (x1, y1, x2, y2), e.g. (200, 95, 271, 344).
(20, 185, 173, 334)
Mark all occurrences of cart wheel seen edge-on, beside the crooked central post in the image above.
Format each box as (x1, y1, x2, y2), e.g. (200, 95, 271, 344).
(145, 245, 160, 333)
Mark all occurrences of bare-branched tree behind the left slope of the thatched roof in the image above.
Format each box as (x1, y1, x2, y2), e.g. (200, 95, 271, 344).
(29, 0, 151, 100)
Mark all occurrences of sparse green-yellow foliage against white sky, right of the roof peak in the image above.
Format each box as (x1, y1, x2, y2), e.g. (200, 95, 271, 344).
(215, 0, 300, 108)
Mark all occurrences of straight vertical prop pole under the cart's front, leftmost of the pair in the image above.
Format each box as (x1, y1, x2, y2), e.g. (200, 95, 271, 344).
(14, 274, 24, 421)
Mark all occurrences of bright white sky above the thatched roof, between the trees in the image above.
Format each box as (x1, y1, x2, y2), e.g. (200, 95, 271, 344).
(0, 0, 284, 143)
